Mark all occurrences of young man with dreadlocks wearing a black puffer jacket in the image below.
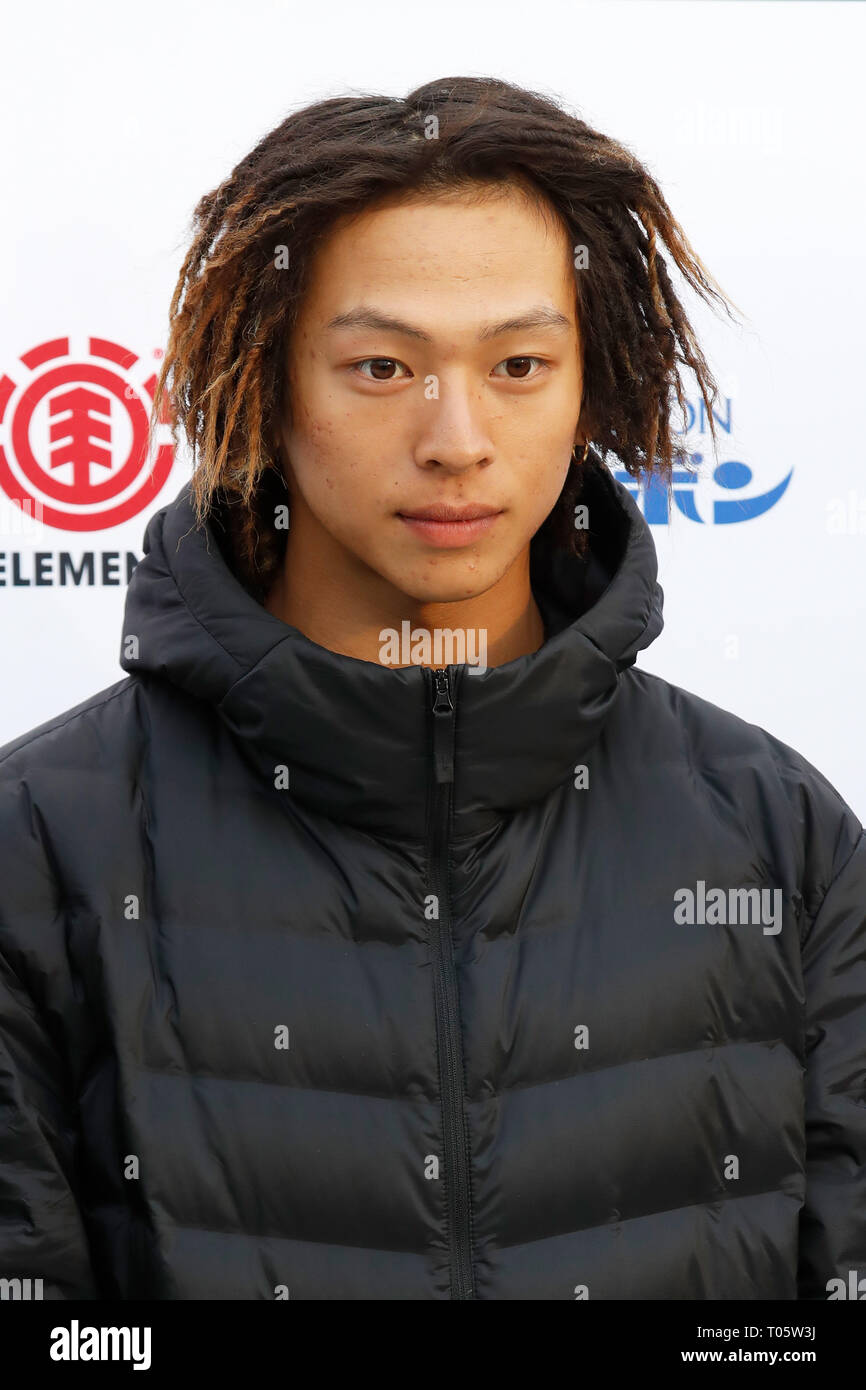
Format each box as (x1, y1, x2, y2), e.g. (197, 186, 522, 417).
(0, 79, 866, 1300)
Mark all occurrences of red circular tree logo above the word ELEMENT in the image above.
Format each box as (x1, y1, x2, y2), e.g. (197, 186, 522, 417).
(0, 338, 174, 531)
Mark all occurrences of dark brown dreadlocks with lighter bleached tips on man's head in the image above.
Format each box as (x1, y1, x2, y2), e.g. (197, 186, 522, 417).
(150, 76, 737, 600)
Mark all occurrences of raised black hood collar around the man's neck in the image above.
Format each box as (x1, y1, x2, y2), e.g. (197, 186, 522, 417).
(121, 459, 663, 841)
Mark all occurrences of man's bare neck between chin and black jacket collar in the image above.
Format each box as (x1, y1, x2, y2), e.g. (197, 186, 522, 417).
(264, 509, 545, 666)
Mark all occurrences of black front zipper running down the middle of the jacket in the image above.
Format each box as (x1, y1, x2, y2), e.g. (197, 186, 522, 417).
(428, 667, 475, 1298)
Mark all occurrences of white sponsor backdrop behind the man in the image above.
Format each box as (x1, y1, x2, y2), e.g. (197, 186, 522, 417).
(0, 0, 866, 817)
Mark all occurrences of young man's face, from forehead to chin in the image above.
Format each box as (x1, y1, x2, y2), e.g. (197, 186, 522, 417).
(281, 188, 581, 603)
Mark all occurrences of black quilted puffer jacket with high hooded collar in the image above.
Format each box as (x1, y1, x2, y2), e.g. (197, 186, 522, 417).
(0, 470, 866, 1300)
